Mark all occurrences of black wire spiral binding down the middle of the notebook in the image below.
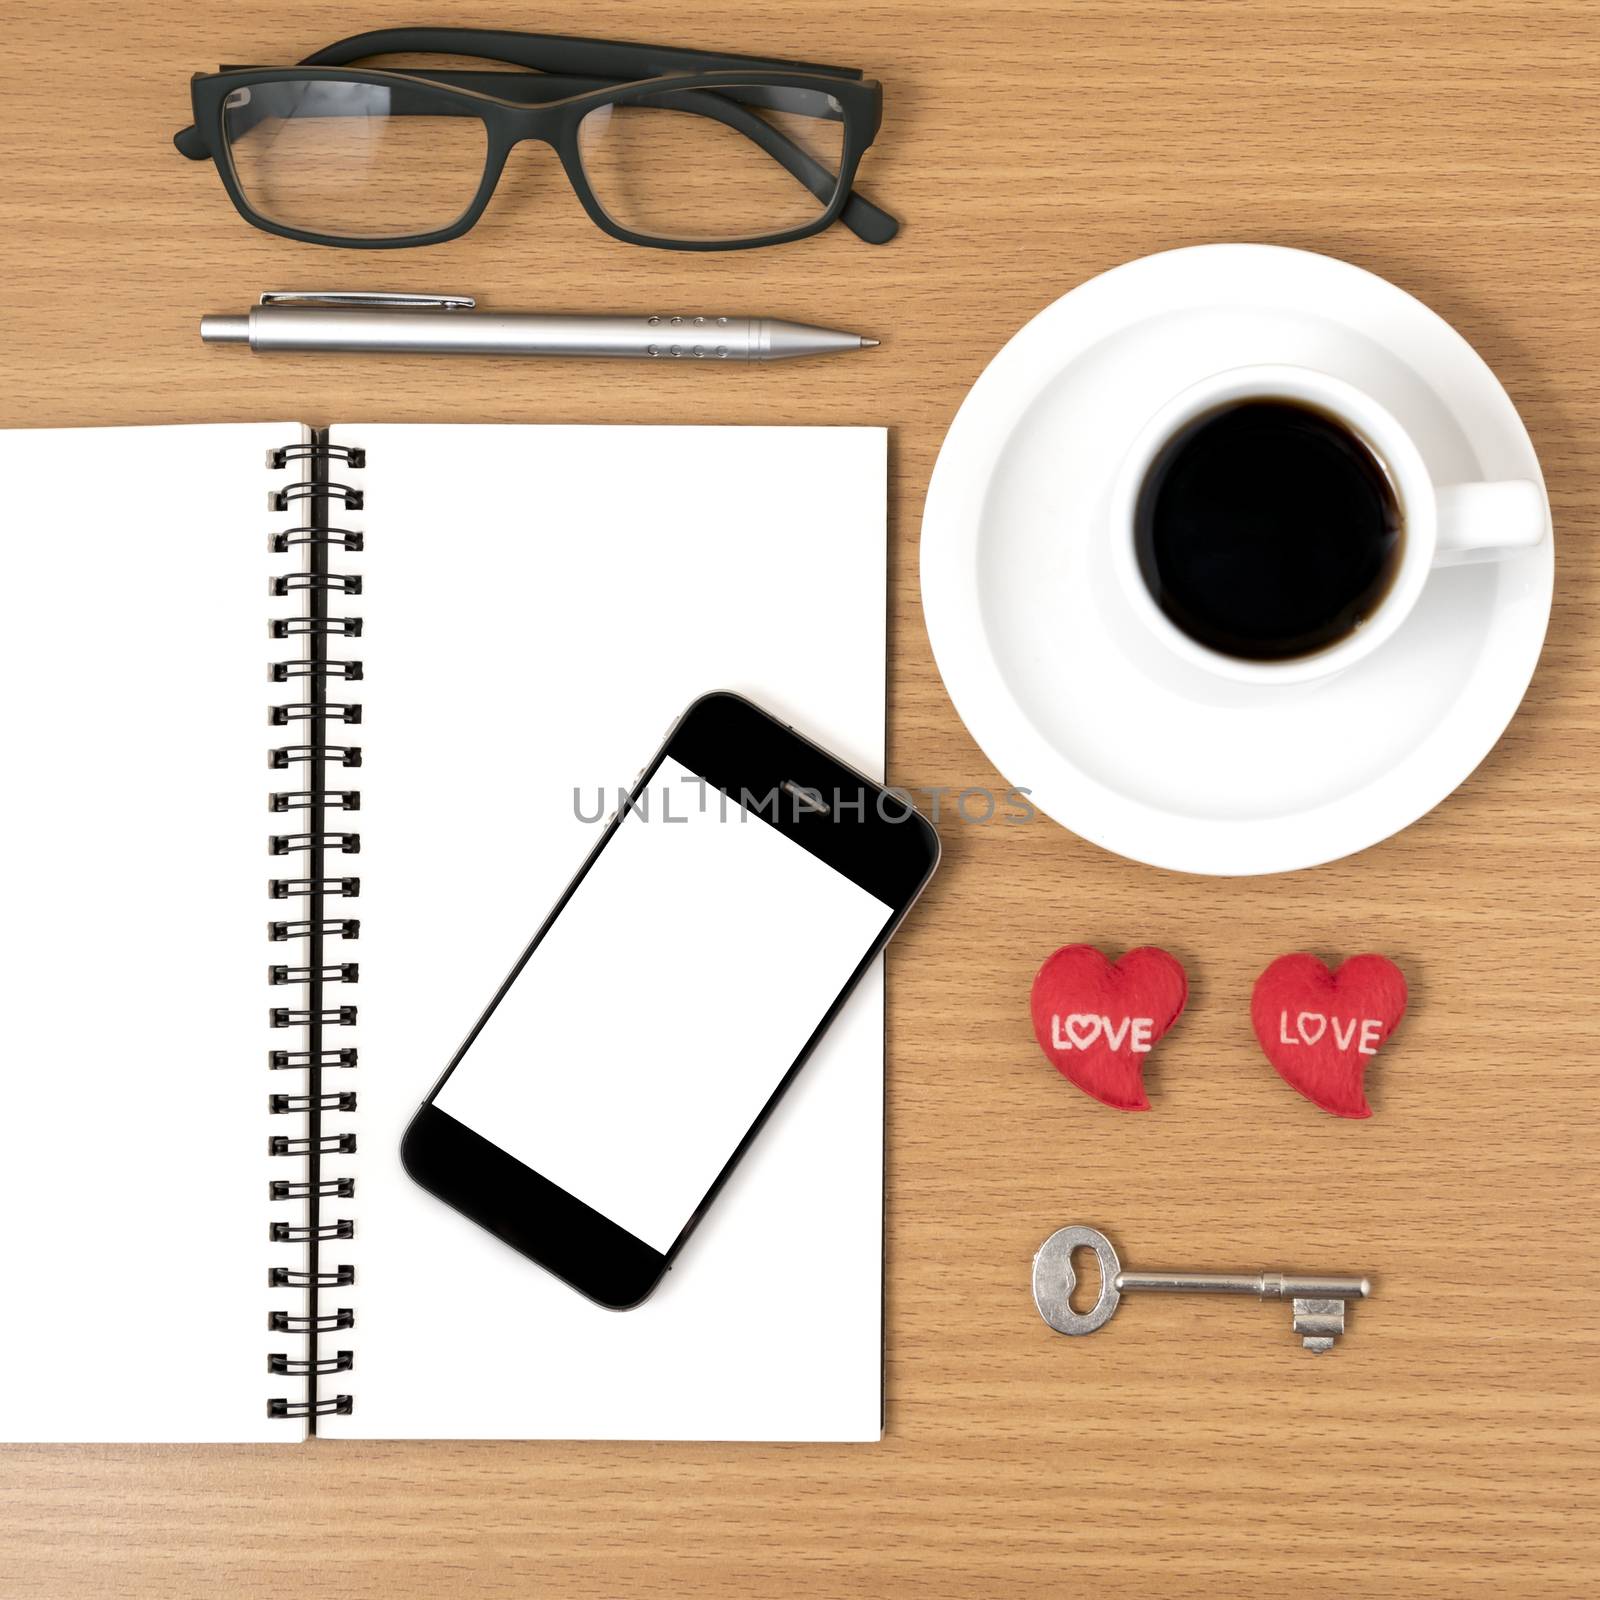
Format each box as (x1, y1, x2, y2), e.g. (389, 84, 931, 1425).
(267, 429, 366, 1434)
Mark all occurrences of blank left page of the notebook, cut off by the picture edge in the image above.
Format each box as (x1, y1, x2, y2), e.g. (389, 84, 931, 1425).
(0, 422, 304, 1442)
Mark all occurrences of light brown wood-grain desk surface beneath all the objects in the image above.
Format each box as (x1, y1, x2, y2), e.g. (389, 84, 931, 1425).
(0, 0, 1600, 1600)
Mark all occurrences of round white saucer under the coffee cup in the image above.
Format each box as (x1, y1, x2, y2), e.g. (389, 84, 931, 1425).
(922, 245, 1555, 874)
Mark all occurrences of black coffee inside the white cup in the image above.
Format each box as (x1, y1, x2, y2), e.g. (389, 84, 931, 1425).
(1134, 400, 1403, 661)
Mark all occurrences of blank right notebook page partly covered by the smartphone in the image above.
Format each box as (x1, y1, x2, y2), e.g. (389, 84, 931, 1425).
(318, 424, 885, 1440)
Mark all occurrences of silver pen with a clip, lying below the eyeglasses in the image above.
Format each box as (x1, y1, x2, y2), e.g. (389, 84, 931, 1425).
(200, 290, 878, 362)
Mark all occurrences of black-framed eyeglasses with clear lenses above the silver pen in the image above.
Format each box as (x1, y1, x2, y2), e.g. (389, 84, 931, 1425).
(173, 27, 899, 250)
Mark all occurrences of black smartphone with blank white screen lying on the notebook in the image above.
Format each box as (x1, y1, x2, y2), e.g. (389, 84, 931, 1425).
(400, 693, 939, 1310)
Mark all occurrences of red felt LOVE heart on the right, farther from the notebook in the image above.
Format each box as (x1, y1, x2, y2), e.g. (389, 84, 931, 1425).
(1250, 955, 1406, 1117)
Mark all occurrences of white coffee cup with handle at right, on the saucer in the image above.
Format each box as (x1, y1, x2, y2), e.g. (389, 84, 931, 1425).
(1110, 366, 1549, 683)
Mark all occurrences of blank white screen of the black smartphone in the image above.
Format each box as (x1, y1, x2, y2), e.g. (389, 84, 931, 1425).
(434, 757, 893, 1253)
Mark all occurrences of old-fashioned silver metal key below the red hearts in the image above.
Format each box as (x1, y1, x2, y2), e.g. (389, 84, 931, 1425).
(1034, 1226, 1373, 1355)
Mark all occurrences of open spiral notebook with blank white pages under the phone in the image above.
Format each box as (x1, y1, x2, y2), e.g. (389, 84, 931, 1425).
(0, 424, 885, 1442)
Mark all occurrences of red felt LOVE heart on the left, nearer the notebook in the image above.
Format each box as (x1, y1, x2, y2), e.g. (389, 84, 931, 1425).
(1032, 944, 1189, 1110)
